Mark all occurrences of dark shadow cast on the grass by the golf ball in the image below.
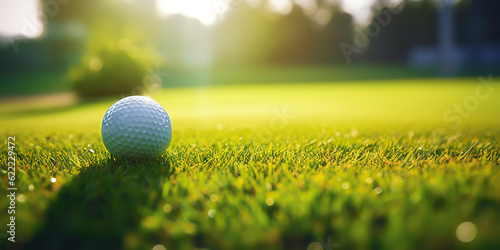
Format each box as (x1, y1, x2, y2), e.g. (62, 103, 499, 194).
(22, 159, 174, 249)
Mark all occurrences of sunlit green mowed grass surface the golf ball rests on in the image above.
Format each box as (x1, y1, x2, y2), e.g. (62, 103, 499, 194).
(0, 79, 500, 249)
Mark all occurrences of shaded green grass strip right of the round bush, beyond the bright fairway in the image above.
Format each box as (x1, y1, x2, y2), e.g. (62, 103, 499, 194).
(162, 64, 440, 87)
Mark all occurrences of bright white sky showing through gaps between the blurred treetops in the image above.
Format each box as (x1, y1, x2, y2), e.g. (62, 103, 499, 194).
(0, 0, 402, 38)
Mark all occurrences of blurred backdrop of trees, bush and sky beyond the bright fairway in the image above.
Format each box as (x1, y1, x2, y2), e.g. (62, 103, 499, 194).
(0, 0, 500, 98)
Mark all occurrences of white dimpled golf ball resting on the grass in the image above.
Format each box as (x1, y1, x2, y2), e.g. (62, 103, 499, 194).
(101, 96, 172, 160)
